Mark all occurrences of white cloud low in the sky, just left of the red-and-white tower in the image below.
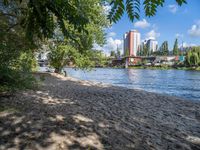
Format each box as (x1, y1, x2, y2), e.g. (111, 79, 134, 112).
(94, 37, 123, 56)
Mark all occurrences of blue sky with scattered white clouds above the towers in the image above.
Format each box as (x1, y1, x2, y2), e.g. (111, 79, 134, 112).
(103, 0, 200, 53)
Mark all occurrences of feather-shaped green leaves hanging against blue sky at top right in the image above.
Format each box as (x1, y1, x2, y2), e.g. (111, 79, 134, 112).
(107, 0, 186, 23)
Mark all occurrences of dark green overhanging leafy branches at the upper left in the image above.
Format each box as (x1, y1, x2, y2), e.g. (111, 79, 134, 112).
(1, 0, 97, 40)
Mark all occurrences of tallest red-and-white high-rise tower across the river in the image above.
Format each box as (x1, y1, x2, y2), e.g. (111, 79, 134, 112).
(124, 30, 140, 56)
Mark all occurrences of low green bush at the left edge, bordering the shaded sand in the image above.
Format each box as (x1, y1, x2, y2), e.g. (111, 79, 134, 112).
(0, 51, 37, 92)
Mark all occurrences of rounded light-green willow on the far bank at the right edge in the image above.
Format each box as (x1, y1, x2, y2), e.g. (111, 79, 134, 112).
(185, 47, 200, 67)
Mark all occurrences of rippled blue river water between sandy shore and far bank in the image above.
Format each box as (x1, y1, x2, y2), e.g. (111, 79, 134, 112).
(66, 68, 200, 100)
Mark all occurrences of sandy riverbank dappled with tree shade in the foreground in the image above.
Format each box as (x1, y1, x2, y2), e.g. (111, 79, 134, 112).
(0, 73, 200, 150)
